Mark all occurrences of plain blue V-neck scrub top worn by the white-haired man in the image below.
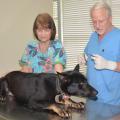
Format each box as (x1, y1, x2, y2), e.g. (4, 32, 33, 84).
(85, 28, 120, 105)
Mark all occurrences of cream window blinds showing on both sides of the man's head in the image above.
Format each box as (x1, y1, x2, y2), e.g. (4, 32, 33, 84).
(55, 0, 120, 74)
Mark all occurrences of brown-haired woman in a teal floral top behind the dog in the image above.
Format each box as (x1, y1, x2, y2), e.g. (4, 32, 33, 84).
(20, 13, 66, 73)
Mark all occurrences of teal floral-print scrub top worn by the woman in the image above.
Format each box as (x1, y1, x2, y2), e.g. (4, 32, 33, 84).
(19, 40, 66, 73)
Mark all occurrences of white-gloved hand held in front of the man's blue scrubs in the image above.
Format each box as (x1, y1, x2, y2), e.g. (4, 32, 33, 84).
(91, 54, 117, 70)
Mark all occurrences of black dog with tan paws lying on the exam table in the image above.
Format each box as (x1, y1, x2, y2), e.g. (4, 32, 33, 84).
(0, 65, 97, 117)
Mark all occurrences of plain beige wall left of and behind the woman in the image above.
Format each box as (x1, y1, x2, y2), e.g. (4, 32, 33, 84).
(0, 0, 52, 76)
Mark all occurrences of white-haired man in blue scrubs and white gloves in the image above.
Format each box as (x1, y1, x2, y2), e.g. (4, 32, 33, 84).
(80, 2, 120, 105)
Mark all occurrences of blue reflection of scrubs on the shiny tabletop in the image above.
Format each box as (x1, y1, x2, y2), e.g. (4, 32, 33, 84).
(85, 100, 120, 120)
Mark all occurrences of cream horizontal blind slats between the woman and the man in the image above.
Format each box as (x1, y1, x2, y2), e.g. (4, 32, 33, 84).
(61, 0, 92, 73)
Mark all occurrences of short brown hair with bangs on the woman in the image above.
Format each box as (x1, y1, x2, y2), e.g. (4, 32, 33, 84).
(33, 13, 56, 40)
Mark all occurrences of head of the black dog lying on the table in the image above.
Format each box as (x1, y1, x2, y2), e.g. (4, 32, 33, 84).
(58, 64, 98, 100)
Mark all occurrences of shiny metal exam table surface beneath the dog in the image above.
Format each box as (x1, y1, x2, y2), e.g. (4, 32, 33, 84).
(0, 100, 120, 120)
